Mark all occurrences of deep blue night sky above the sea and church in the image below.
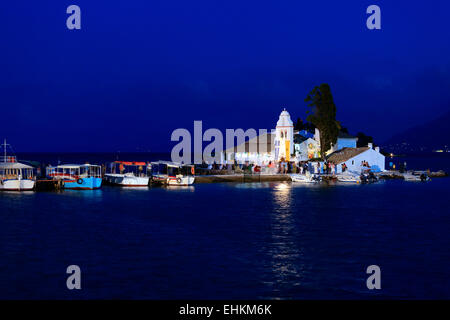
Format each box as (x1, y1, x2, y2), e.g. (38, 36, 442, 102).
(0, 0, 450, 152)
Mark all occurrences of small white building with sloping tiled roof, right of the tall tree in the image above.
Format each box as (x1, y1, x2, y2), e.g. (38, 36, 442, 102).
(327, 143, 386, 173)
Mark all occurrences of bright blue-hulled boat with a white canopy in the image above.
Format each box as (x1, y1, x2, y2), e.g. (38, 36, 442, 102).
(46, 164, 102, 190)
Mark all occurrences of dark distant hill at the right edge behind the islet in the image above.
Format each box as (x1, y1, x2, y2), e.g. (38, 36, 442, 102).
(383, 111, 450, 152)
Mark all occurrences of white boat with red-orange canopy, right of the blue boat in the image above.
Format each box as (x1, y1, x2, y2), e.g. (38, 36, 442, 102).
(104, 161, 151, 187)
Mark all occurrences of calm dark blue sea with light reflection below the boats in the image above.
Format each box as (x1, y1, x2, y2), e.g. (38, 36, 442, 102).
(0, 154, 450, 299)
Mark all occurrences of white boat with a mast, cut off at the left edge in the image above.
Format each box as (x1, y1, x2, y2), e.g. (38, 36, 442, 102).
(0, 140, 36, 191)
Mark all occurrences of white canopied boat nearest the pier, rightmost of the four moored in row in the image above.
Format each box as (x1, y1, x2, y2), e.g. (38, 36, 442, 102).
(151, 161, 195, 186)
